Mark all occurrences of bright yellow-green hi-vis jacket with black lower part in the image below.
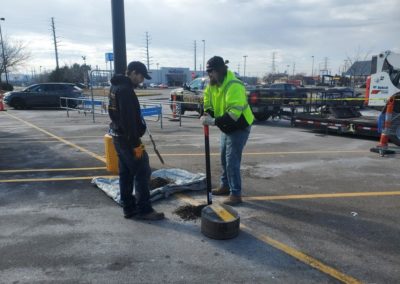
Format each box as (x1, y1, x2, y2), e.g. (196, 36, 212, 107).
(204, 70, 254, 132)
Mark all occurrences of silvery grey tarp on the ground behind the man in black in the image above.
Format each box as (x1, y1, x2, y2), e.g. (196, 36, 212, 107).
(92, 169, 206, 204)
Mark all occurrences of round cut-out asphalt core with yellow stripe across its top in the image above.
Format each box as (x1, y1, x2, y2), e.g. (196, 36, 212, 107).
(201, 204, 240, 240)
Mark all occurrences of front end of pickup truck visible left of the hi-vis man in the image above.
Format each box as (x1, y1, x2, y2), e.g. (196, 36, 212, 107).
(170, 77, 209, 115)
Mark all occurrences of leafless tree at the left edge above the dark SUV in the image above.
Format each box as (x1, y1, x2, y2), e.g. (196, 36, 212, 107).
(0, 37, 31, 82)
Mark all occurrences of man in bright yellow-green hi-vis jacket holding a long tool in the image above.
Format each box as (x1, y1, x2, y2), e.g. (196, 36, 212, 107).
(201, 56, 254, 205)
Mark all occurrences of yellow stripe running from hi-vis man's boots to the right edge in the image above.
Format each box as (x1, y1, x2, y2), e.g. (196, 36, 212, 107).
(243, 191, 400, 201)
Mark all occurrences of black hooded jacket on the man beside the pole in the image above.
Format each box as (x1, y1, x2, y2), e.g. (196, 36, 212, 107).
(108, 75, 146, 147)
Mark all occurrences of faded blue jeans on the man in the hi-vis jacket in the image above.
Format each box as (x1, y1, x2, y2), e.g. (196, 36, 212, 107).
(221, 126, 251, 196)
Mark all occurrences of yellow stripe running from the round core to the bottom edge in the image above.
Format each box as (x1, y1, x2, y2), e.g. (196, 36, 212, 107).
(240, 224, 361, 284)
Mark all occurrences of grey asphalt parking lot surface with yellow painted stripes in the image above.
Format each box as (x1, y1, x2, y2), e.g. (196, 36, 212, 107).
(0, 98, 400, 283)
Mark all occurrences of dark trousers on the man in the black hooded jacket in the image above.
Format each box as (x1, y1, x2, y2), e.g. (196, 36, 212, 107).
(113, 136, 153, 214)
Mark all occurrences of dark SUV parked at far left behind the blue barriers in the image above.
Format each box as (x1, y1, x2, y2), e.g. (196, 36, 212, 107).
(4, 83, 82, 109)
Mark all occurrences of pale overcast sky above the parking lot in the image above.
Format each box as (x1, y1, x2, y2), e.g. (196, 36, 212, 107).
(0, 0, 400, 76)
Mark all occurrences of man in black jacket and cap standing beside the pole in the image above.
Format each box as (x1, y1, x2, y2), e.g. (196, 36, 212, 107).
(108, 61, 164, 220)
